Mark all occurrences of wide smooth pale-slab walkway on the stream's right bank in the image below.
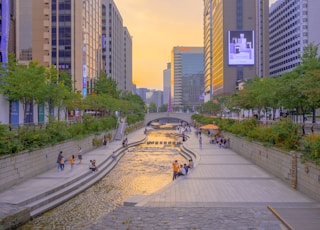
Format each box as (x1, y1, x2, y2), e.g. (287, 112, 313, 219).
(138, 133, 314, 207)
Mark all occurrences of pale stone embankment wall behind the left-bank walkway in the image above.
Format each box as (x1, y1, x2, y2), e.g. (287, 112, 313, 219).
(0, 134, 104, 192)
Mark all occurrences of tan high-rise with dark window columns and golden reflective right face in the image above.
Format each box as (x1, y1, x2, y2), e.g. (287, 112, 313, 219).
(29, 0, 101, 96)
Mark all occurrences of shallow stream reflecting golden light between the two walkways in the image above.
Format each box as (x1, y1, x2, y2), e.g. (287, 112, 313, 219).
(19, 130, 187, 230)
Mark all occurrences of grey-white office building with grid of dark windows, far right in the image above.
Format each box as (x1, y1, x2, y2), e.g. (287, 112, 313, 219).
(269, 0, 320, 77)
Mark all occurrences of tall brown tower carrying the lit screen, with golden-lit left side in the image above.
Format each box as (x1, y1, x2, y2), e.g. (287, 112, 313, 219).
(204, 0, 269, 101)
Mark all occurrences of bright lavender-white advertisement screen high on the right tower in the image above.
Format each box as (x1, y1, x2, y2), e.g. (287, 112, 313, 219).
(228, 30, 254, 65)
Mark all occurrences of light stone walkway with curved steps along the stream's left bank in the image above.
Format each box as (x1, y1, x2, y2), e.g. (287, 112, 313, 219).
(0, 130, 146, 229)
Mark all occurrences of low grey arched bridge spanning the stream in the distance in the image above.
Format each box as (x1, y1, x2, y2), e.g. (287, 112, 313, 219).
(144, 112, 192, 126)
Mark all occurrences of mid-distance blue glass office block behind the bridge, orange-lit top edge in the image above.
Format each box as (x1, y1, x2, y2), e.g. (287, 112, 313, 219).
(171, 47, 204, 110)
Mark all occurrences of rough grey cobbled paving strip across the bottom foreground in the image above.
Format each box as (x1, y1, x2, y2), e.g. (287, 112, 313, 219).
(87, 206, 281, 230)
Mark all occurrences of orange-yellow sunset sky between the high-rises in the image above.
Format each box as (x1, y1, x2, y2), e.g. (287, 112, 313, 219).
(114, 0, 203, 90)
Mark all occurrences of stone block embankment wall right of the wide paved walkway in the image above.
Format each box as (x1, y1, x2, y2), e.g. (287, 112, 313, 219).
(225, 133, 320, 201)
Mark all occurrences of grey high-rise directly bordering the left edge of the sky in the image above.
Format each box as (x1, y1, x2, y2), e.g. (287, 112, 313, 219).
(102, 0, 132, 92)
